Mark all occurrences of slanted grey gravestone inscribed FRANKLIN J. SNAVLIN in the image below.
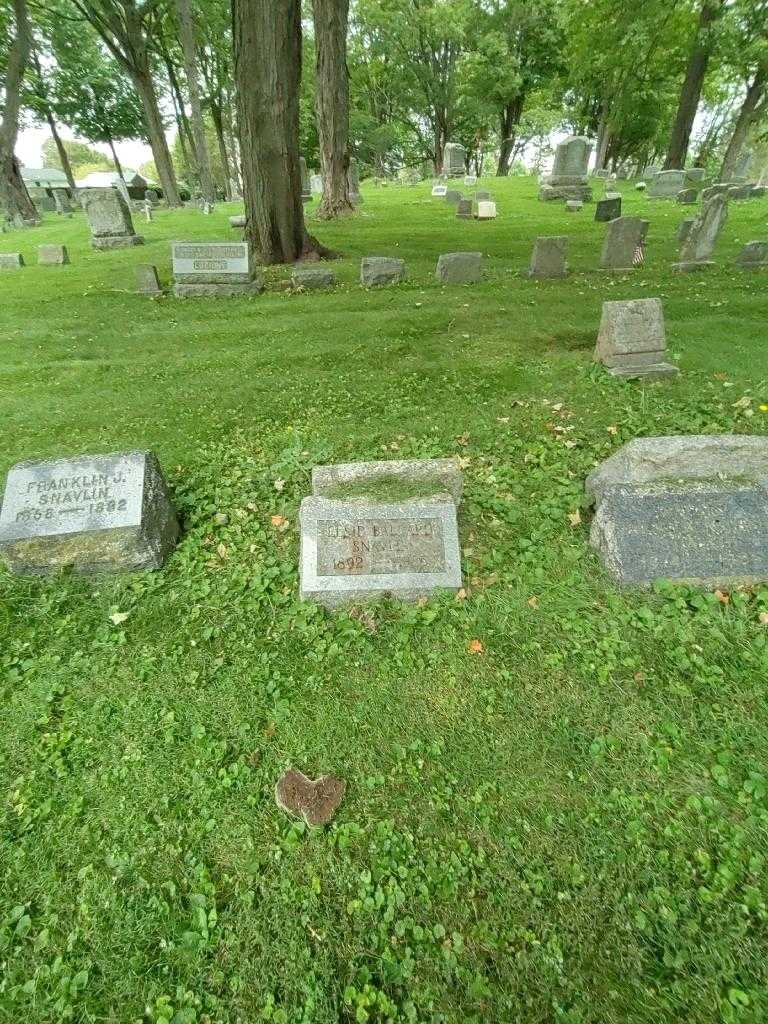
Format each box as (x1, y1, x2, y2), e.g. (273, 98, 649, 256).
(0, 452, 179, 575)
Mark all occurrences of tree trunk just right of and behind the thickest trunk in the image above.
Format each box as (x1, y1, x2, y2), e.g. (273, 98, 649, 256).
(312, 0, 352, 220)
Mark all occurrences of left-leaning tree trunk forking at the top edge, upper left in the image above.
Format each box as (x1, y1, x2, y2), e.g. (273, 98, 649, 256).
(72, 0, 181, 206)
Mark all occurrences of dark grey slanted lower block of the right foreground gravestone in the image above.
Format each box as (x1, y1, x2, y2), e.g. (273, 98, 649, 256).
(590, 479, 768, 588)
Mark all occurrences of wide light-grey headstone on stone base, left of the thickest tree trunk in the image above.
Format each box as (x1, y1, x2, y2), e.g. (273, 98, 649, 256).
(171, 242, 264, 298)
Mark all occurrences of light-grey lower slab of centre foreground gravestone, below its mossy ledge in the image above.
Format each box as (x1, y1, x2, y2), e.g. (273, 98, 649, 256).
(300, 497, 462, 607)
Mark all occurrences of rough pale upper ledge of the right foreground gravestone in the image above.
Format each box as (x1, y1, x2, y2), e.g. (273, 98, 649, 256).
(586, 434, 768, 502)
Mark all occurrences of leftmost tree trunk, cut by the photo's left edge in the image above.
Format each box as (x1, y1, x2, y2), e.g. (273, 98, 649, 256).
(0, 0, 40, 226)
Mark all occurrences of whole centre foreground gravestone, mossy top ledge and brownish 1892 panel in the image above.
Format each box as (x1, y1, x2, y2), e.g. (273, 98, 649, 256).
(300, 459, 462, 607)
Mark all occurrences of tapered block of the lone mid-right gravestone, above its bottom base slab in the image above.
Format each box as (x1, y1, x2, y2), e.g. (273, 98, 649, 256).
(595, 299, 667, 367)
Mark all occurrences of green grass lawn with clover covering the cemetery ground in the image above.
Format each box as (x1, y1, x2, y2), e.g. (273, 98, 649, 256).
(0, 179, 768, 1024)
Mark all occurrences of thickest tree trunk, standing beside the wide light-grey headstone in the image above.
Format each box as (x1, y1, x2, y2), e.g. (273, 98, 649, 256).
(232, 0, 327, 263)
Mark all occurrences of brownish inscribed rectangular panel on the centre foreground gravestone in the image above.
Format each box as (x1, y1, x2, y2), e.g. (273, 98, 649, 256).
(317, 518, 445, 577)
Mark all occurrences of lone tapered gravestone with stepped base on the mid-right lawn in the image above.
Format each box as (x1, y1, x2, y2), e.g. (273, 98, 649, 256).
(595, 299, 678, 378)
